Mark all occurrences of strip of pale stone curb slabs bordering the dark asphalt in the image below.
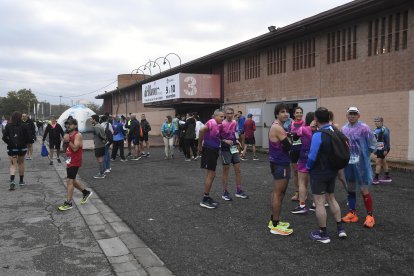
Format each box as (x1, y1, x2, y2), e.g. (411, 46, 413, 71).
(49, 140, 174, 276)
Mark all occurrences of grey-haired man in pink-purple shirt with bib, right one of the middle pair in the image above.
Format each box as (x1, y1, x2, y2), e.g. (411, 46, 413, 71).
(221, 107, 248, 201)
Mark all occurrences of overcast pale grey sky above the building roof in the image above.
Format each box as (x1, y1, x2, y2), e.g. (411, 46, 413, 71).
(0, 0, 350, 104)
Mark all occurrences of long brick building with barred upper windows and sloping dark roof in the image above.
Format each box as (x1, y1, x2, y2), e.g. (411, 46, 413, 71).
(97, 0, 414, 161)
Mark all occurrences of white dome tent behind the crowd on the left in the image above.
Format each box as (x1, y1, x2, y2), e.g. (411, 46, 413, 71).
(58, 104, 95, 132)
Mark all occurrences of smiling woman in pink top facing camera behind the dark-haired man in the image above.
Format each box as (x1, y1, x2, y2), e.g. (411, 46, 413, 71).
(289, 106, 305, 201)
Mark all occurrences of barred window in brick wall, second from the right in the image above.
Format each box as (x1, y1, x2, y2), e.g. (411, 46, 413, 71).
(326, 26, 357, 64)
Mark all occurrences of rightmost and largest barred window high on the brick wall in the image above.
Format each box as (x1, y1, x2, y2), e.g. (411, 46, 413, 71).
(368, 11, 408, 56)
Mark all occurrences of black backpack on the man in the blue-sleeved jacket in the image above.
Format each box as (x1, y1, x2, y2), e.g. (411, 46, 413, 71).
(319, 127, 350, 170)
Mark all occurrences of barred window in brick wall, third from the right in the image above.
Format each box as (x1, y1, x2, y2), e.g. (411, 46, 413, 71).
(293, 38, 316, 71)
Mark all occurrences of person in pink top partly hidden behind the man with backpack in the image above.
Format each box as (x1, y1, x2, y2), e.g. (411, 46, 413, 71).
(292, 112, 315, 214)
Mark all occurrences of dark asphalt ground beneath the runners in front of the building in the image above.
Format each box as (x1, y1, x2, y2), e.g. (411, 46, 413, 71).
(80, 148, 414, 276)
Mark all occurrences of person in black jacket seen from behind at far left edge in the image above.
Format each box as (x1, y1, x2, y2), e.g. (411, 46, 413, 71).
(2, 111, 30, 191)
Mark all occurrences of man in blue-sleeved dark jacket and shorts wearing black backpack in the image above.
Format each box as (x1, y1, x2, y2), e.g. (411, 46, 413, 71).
(308, 107, 347, 243)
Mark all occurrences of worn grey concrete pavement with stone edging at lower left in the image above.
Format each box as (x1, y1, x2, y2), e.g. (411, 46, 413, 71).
(0, 142, 172, 275)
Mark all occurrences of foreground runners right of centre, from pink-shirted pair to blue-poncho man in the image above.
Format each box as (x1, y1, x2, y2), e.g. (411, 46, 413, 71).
(198, 103, 391, 243)
